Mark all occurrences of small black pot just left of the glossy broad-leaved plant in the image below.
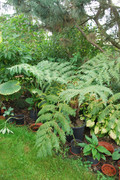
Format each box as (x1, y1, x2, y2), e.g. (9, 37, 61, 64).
(70, 139, 82, 155)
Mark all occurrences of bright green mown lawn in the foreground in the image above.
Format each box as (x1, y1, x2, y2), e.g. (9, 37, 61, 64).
(0, 120, 101, 180)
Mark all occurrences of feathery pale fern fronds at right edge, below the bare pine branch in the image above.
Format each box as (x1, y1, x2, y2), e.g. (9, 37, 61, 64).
(78, 52, 120, 86)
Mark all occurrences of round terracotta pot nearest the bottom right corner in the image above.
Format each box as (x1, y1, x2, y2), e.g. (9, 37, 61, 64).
(101, 164, 116, 176)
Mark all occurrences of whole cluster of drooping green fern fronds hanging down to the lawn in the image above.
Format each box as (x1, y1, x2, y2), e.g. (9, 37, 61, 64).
(36, 98, 75, 157)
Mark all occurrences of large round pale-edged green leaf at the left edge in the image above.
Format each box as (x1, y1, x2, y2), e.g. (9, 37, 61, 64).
(0, 80, 21, 95)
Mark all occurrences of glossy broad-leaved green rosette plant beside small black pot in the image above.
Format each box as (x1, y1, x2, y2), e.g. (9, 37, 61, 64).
(79, 134, 111, 166)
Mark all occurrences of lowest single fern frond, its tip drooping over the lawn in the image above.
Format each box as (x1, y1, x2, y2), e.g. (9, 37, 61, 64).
(36, 121, 66, 158)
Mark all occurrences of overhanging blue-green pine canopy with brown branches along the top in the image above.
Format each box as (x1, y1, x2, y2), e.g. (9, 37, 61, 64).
(8, 0, 120, 52)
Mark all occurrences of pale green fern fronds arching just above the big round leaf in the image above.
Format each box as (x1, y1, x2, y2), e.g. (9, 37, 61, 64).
(8, 61, 74, 87)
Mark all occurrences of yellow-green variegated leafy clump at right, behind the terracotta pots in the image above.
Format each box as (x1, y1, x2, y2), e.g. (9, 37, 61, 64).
(86, 93, 120, 145)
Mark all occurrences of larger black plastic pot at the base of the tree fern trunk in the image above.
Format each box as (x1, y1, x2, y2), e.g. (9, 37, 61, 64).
(72, 123, 85, 141)
